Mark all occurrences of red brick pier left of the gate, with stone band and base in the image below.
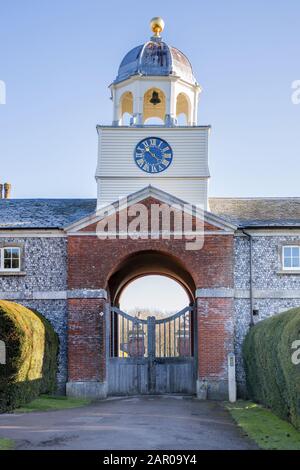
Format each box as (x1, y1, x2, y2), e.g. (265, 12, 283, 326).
(66, 290, 107, 398)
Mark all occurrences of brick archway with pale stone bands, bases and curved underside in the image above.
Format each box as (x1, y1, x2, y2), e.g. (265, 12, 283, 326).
(67, 190, 234, 398)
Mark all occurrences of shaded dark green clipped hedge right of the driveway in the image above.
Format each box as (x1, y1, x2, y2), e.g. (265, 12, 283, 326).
(243, 308, 300, 429)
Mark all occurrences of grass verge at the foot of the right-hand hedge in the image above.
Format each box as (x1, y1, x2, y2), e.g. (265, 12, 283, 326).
(225, 400, 300, 450)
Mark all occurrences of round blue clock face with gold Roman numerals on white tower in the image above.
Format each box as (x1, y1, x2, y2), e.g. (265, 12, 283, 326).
(134, 137, 173, 173)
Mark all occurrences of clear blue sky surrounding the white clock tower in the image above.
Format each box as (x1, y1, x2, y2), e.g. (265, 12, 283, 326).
(0, 0, 300, 198)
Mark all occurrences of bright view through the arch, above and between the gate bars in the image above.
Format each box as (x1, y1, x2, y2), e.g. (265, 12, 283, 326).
(114, 274, 193, 360)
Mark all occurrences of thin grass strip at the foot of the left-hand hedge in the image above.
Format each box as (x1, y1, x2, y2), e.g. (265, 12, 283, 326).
(15, 395, 91, 413)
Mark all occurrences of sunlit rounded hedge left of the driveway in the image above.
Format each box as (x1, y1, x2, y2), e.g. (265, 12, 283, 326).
(0, 300, 58, 412)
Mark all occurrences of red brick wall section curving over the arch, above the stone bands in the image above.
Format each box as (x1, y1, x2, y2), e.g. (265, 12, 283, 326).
(68, 235, 233, 289)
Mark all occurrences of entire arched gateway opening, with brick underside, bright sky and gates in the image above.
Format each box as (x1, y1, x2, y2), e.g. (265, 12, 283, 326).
(107, 250, 197, 395)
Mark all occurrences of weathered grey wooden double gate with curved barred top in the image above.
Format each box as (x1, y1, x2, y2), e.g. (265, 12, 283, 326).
(106, 307, 197, 395)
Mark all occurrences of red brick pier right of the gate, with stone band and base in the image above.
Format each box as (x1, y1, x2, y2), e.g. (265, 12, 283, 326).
(197, 289, 234, 399)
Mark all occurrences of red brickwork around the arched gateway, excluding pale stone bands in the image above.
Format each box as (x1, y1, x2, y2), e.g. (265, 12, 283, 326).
(68, 201, 233, 386)
